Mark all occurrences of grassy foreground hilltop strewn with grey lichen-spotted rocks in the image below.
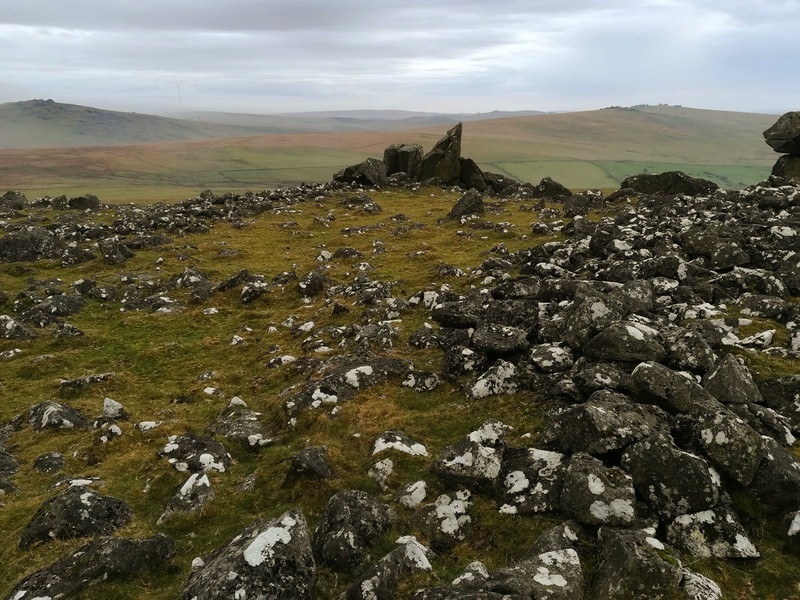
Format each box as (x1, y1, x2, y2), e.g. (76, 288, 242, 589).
(0, 175, 800, 600)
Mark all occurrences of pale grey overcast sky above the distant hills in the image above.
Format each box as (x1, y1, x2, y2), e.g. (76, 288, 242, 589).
(0, 0, 800, 113)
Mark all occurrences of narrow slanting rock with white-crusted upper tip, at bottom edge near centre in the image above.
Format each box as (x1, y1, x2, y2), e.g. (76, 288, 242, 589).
(345, 536, 431, 600)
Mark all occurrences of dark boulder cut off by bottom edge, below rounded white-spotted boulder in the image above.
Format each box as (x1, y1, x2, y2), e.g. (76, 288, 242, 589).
(592, 528, 683, 599)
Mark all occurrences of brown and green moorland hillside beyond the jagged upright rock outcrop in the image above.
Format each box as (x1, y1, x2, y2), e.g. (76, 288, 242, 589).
(0, 105, 775, 202)
